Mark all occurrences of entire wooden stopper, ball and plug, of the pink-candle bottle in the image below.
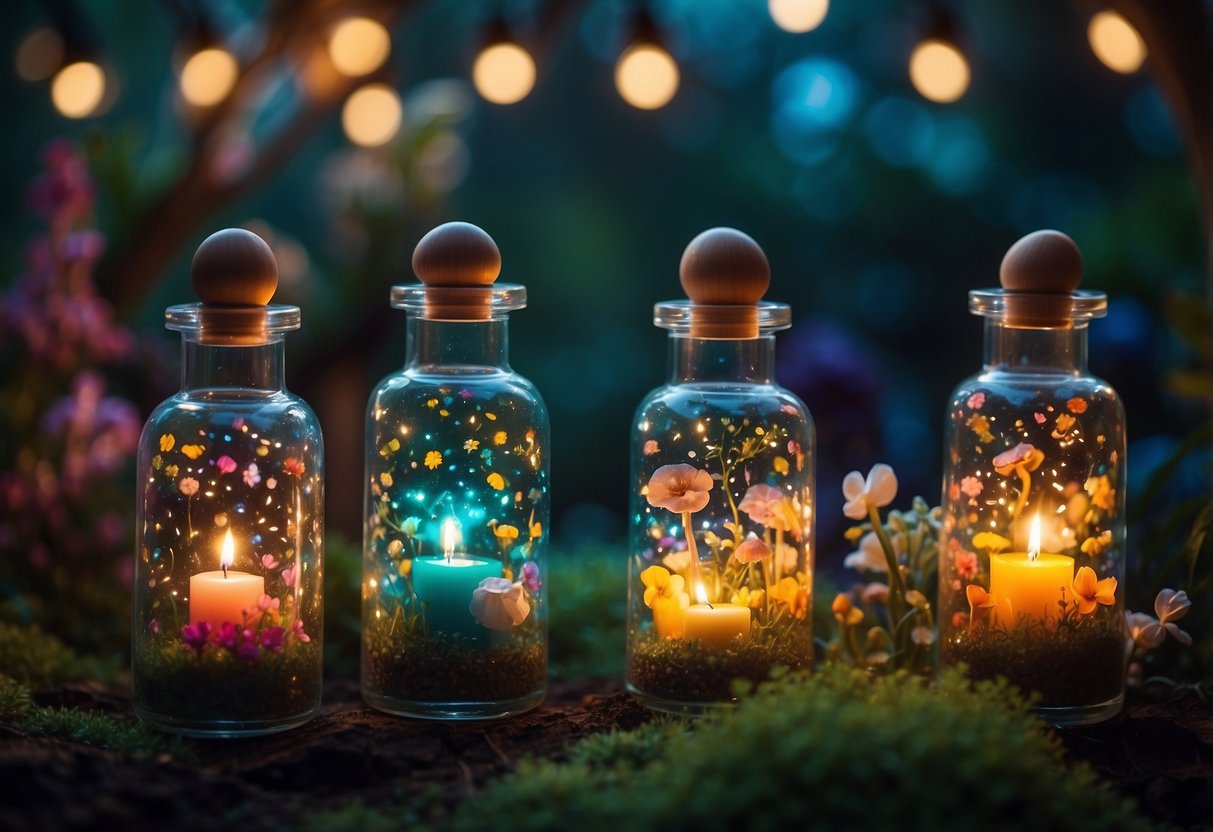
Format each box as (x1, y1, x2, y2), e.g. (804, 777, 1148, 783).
(189, 228, 278, 346)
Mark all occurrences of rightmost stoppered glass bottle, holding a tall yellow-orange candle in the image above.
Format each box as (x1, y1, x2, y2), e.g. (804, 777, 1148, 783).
(939, 230, 1124, 725)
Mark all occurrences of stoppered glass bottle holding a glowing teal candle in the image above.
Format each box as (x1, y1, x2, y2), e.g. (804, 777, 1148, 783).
(361, 222, 551, 719)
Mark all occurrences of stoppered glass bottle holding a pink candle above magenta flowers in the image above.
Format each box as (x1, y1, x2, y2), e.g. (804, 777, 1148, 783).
(132, 228, 324, 736)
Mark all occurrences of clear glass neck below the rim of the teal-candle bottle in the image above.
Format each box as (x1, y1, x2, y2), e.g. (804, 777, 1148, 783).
(404, 317, 509, 374)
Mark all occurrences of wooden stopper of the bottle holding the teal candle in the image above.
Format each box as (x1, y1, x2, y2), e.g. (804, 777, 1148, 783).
(412, 222, 501, 320)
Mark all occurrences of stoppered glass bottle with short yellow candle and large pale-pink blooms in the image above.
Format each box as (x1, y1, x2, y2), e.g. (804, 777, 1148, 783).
(626, 228, 815, 713)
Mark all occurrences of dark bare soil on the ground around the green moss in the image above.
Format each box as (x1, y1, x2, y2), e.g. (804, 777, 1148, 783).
(0, 679, 1213, 832)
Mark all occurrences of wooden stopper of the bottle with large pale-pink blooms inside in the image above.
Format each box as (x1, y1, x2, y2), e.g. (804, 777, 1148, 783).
(678, 228, 770, 338)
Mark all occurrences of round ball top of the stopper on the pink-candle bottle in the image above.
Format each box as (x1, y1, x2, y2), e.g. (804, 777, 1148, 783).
(189, 228, 278, 307)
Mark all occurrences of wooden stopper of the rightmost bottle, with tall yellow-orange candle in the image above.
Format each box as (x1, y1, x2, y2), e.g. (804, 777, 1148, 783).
(998, 230, 1082, 326)
